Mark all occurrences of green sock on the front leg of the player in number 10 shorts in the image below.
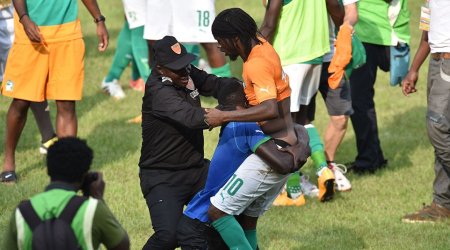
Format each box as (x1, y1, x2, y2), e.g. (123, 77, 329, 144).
(212, 215, 253, 250)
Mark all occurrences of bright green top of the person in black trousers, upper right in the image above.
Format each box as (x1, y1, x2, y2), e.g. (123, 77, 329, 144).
(355, 0, 411, 46)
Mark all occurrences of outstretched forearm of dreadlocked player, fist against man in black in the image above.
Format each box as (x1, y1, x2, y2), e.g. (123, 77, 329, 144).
(205, 99, 278, 128)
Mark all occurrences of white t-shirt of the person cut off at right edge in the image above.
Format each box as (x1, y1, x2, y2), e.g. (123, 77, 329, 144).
(428, 0, 450, 53)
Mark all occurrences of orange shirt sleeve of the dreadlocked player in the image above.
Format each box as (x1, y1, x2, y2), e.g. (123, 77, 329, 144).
(245, 59, 277, 103)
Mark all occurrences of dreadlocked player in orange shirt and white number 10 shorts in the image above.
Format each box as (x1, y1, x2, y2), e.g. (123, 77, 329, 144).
(205, 8, 310, 249)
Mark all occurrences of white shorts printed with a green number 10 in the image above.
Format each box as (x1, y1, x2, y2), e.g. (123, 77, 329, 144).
(211, 154, 289, 217)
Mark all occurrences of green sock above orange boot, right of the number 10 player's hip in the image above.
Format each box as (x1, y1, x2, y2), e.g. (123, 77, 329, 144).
(305, 124, 328, 173)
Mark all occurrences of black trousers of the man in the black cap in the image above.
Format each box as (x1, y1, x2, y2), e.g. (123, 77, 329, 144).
(139, 162, 209, 250)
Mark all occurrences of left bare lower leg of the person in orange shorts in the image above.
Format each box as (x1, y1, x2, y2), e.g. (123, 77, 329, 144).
(3, 99, 30, 175)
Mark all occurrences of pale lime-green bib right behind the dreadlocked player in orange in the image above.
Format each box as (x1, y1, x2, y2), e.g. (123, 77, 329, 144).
(273, 0, 330, 66)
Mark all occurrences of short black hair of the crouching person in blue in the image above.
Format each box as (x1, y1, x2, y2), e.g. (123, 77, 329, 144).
(217, 78, 247, 111)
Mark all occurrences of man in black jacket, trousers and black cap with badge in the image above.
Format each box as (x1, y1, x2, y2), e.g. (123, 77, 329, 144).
(139, 36, 230, 249)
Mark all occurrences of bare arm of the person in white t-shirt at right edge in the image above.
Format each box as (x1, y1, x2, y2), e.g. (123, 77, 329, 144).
(402, 31, 430, 96)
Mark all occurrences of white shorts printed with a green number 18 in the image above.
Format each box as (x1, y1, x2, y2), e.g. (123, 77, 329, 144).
(144, 0, 217, 43)
